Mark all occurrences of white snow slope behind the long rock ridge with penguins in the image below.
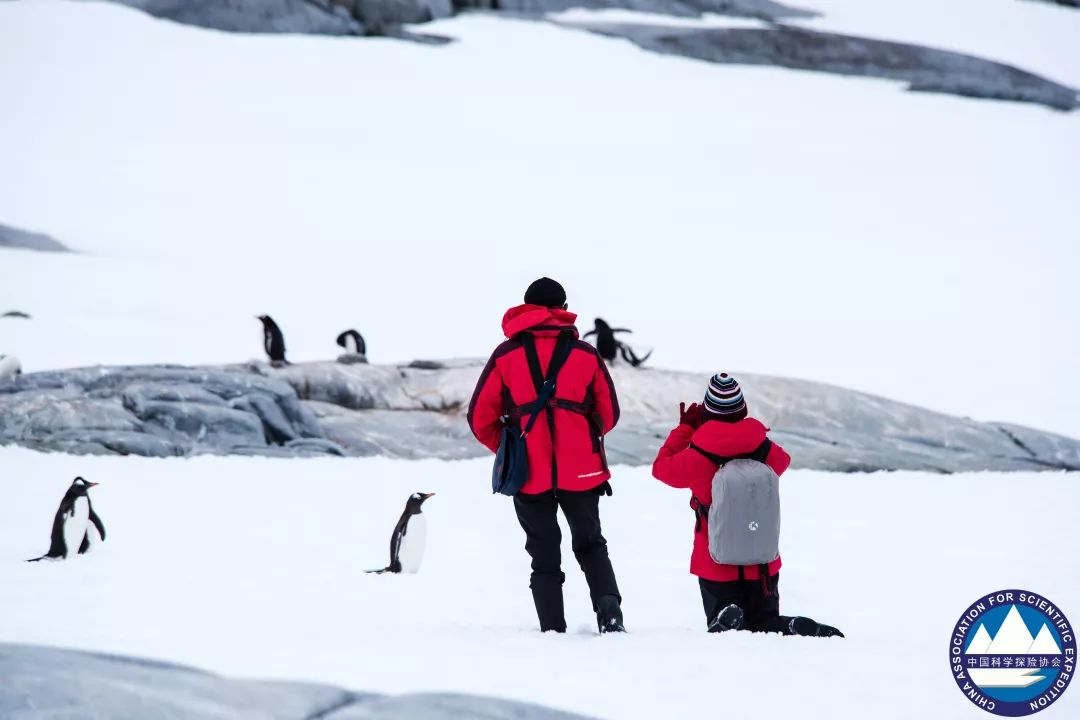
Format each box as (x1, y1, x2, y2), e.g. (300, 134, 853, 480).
(0, 0, 1080, 436)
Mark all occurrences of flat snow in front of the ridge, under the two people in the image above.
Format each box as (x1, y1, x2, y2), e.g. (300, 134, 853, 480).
(0, 448, 1080, 719)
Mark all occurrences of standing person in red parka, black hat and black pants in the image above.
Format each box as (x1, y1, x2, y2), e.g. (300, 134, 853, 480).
(469, 277, 624, 633)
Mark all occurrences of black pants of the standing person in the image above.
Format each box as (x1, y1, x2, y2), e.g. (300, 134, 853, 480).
(514, 490, 622, 633)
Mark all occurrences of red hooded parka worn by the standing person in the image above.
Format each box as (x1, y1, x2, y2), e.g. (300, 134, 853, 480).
(469, 304, 619, 494)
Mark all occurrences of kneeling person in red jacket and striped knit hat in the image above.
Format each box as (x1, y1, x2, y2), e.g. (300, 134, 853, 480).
(652, 372, 843, 637)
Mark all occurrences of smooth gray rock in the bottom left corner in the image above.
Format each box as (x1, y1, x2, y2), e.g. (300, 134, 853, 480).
(0, 643, 588, 720)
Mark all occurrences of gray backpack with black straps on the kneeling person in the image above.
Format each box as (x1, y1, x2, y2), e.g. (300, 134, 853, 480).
(690, 439, 780, 566)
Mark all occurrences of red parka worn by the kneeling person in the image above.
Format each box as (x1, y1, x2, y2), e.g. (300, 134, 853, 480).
(652, 418, 792, 582)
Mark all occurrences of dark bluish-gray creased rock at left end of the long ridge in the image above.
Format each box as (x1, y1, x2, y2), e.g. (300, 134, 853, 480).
(0, 366, 328, 457)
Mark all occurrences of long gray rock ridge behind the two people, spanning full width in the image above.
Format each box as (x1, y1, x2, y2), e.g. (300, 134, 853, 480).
(0, 361, 1080, 473)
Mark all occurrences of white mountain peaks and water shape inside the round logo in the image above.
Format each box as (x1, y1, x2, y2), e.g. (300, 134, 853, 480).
(964, 606, 1062, 688)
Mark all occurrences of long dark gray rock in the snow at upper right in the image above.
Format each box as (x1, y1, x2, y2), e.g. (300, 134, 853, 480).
(571, 23, 1080, 110)
